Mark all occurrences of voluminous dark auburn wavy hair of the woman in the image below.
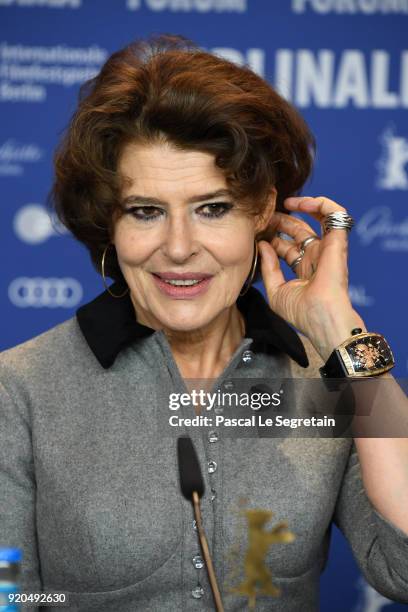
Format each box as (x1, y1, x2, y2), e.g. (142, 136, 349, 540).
(49, 34, 315, 280)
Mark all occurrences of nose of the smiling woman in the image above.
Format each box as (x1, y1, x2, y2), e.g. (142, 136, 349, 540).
(162, 215, 198, 263)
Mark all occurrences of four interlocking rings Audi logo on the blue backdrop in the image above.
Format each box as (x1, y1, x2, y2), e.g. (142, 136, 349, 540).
(8, 276, 83, 308)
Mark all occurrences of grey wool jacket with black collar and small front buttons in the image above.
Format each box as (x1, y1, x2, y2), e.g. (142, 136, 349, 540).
(0, 289, 408, 612)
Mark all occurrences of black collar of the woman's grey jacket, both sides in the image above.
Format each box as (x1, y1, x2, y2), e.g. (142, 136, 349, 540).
(76, 283, 309, 369)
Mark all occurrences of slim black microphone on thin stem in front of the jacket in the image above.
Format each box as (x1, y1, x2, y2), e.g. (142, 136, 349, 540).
(177, 436, 224, 612)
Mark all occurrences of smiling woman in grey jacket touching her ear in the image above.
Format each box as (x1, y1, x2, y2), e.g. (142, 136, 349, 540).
(0, 36, 408, 612)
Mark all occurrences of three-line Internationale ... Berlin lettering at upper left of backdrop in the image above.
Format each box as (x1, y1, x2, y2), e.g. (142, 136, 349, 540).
(0, 43, 108, 103)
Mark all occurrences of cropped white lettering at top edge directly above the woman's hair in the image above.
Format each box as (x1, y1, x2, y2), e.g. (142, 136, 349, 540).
(126, 0, 247, 13)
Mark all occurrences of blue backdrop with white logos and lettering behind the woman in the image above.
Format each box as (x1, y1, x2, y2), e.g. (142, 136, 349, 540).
(0, 0, 408, 612)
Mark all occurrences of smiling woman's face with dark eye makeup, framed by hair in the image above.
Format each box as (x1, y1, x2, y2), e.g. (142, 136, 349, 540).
(113, 144, 276, 331)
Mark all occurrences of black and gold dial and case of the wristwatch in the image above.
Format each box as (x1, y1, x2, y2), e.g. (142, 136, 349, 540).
(345, 334, 393, 373)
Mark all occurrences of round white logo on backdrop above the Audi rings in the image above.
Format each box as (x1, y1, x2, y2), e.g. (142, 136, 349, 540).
(13, 204, 68, 244)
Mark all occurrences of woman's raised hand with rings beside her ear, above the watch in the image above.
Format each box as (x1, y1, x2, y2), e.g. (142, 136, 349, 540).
(258, 197, 365, 360)
